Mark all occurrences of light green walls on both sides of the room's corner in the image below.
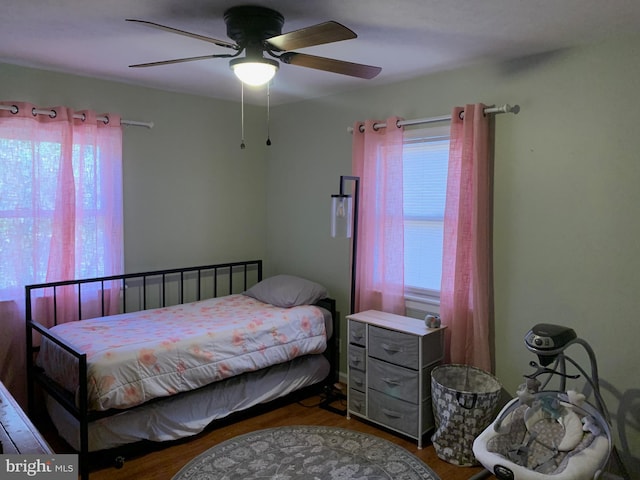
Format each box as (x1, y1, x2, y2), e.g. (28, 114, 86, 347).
(0, 31, 640, 472)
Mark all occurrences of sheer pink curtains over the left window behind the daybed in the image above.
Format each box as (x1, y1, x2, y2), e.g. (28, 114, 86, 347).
(0, 102, 124, 404)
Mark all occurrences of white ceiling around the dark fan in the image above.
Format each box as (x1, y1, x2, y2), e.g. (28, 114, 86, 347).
(0, 0, 640, 105)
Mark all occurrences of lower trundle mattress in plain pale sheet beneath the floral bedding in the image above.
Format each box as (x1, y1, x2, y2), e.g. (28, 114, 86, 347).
(47, 355, 330, 452)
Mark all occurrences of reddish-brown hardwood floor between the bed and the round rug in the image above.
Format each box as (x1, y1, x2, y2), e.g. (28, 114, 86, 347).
(43, 396, 494, 480)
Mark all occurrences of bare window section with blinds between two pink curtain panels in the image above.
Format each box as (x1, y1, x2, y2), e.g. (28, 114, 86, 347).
(403, 126, 449, 300)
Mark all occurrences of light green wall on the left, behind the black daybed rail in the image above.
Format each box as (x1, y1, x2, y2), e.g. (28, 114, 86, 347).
(0, 64, 267, 272)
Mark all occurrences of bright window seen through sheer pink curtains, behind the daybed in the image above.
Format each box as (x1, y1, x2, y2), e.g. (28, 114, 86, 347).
(0, 121, 122, 292)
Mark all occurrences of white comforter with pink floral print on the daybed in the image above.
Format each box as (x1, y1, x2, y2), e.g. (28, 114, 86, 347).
(38, 295, 326, 410)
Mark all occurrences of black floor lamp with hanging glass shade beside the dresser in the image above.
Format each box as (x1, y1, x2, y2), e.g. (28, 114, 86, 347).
(321, 175, 360, 415)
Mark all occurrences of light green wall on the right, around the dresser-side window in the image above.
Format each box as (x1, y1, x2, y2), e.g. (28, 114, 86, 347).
(267, 37, 640, 471)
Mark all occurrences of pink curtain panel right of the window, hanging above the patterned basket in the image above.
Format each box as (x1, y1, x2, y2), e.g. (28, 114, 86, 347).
(440, 104, 493, 371)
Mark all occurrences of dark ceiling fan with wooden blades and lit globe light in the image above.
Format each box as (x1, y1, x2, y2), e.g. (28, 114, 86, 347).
(127, 6, 382, 85)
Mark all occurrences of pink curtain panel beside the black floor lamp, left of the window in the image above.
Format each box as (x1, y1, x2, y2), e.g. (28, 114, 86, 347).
(352, 117, 405, 314)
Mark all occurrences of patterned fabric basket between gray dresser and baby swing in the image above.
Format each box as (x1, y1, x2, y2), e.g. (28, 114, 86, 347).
(431, 364, 502, 466)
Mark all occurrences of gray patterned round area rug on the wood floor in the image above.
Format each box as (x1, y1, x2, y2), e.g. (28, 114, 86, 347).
(173, 426, 439, 480)
